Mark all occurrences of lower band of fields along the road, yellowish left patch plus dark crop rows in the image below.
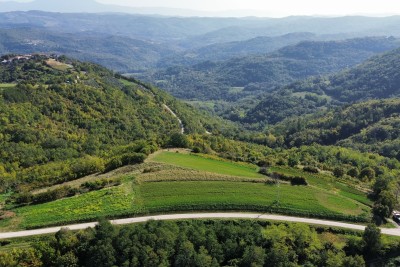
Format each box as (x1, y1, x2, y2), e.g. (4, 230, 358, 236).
(0, 178, 368, 230)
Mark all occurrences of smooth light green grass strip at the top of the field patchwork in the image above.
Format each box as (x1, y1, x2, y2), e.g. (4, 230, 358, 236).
(152, 152, 265, 178)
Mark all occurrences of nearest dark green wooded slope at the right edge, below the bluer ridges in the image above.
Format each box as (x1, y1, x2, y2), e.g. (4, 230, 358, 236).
(273, 98, 400, 159)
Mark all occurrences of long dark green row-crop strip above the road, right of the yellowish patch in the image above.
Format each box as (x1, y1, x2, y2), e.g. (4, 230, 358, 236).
(140, 181, 368, 218)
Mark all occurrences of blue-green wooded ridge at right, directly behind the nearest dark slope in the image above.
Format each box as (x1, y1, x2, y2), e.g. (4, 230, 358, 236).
(241, 46, 400, 127)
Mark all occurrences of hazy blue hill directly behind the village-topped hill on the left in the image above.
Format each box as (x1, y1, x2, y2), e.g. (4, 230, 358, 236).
(0, 27, 176, 72)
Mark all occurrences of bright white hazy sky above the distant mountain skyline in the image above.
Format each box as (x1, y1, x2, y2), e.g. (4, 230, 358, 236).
(98, 0, 400, 16)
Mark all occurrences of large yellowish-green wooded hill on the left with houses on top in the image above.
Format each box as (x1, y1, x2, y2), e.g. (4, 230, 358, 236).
(0, 56, 224, 193)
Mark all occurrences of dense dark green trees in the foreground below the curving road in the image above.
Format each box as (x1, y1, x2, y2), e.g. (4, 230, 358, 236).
(0, 220, 400, 267)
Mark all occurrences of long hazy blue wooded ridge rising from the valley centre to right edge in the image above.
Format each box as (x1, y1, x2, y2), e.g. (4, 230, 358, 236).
(148, 37, 399, 101)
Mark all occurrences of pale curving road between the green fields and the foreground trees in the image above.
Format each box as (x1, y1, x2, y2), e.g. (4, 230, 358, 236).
(0, 213, 400, 239)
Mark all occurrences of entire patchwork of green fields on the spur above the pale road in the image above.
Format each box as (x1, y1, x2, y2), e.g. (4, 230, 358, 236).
(0, 152, 370, 231)
